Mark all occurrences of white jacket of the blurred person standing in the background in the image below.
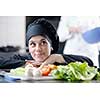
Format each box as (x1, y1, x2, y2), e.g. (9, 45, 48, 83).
(57, 16, 100, 66)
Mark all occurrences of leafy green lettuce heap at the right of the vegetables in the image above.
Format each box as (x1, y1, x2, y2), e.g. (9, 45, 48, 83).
(51, 62, 98, 81)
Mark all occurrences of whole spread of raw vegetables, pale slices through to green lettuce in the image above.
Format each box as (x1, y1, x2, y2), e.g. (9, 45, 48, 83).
(10, 62, 100, 82)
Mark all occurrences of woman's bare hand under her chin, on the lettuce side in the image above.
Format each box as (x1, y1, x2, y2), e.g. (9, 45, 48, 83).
(39, 54, 65, 69)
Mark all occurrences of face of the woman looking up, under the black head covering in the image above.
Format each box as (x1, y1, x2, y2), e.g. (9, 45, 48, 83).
(29, 35, 52, 62)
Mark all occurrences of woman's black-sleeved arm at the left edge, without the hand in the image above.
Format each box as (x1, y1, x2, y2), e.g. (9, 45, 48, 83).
(0, 54, 26, 69)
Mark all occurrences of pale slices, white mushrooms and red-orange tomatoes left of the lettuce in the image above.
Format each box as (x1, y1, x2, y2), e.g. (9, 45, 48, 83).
(10, 63, 57, 77)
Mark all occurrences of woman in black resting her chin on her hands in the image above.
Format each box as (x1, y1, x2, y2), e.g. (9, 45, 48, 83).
(0, 18, 93, 69)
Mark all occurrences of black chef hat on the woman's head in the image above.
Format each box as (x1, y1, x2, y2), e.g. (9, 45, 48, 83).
(26, 18, 59, 53)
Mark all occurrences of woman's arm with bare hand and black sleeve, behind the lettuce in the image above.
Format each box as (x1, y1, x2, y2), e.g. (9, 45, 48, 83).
(40, 54, 93, 68)
